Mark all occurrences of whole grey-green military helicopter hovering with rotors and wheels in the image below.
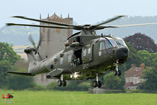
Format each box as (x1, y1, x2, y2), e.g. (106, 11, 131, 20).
(7, 15, 157, 88)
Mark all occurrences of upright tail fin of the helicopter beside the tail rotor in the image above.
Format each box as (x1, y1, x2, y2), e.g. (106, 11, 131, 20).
(24, 47, 37, 62)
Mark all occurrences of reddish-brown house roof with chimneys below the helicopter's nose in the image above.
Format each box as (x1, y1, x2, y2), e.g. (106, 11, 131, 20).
(125, 64, 145, 77)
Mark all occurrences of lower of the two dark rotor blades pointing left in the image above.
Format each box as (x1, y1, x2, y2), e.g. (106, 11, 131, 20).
(6, 23, 74, 29)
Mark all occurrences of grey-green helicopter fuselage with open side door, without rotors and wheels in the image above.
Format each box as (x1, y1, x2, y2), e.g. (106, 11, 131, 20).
(25, 35, 128, 79)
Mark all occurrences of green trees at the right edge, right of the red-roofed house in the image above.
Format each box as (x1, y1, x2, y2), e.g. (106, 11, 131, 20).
(138, 50, 157, 91)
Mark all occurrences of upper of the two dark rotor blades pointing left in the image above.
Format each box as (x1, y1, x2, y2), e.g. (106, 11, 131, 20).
(13, 16, 74, 27)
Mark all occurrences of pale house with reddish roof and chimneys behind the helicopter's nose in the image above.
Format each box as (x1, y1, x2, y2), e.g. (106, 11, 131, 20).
(125, 63, 145, 90)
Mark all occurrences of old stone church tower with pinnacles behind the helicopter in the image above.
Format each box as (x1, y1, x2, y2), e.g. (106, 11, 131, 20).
(34, 13, 73, 85)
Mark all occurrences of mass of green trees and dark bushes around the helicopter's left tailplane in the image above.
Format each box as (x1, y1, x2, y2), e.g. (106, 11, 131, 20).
(0, 43, 33, 90)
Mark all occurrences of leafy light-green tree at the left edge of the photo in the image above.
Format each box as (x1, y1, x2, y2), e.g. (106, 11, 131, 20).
(0, 43, 19, 88)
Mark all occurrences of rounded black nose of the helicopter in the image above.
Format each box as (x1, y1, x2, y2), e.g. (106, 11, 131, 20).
(116, 48, 128, 60)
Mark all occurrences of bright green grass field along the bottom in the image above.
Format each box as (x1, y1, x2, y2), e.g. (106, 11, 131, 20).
(0, 90, 157, 105)
